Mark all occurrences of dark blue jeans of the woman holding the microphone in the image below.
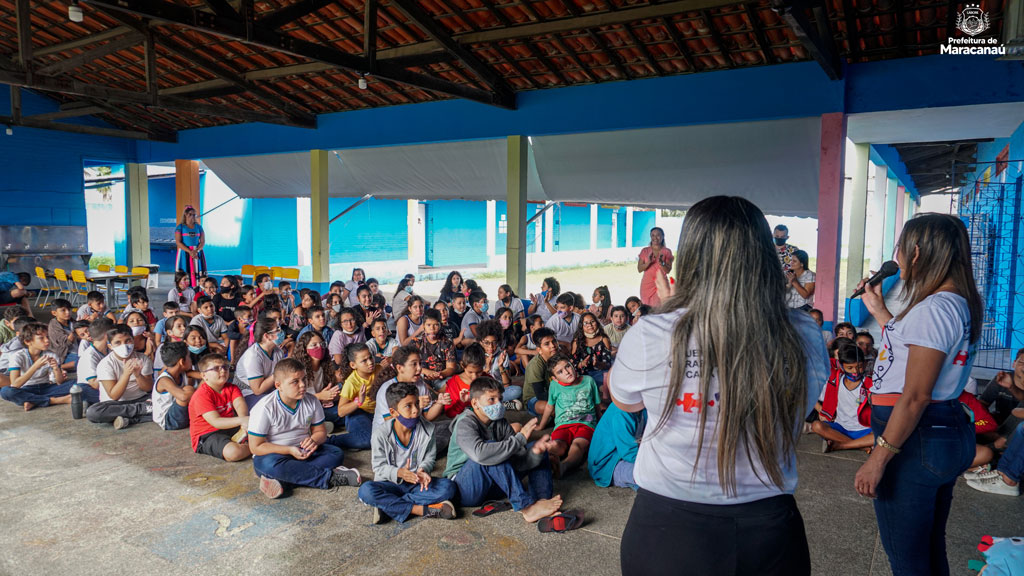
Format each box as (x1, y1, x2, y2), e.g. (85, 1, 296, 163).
(871, 400, 975, 576)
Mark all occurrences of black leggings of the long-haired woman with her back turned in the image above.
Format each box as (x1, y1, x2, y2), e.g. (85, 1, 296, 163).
(622, 488, 811, 576)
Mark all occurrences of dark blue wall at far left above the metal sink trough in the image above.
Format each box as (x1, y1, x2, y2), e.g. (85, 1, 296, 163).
(0, 89, 135, 227)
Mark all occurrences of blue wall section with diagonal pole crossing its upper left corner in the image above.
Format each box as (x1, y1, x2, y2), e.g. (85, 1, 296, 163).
(328, 198, 409, 263)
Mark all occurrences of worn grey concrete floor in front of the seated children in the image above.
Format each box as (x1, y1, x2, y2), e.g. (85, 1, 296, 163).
(0, 403, 1024, 576)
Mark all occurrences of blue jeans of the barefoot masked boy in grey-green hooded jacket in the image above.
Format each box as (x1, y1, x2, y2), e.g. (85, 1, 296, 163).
(453, 444, 554, 511)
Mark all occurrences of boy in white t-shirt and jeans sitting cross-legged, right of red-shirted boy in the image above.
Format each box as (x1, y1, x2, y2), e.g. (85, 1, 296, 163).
(248, 358, 361, 498)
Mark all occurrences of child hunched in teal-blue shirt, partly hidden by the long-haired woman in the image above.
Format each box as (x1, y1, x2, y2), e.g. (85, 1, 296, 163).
(587, 404, 647, 490)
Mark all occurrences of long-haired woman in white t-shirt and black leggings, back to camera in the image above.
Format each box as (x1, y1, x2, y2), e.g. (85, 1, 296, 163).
(609, 196, 828, 576)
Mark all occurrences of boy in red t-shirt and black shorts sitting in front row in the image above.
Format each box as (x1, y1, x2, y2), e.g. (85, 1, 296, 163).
(188, 354, 252, 462)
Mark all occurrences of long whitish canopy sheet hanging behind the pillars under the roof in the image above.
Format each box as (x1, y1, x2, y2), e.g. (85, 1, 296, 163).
(199, 117, 820, 216)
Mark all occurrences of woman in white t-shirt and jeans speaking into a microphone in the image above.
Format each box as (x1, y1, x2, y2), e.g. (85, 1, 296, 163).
(854, 214, 983, 576)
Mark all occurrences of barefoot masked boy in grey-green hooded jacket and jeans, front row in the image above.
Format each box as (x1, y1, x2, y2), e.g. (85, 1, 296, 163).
(444, 376, 562, 523)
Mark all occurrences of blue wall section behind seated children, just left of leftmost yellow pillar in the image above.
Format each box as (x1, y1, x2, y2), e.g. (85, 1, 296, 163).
(250, 198, 299, 268)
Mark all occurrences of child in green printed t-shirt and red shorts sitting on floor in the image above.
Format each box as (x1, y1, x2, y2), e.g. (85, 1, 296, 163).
(538, 352, 601, 471)
